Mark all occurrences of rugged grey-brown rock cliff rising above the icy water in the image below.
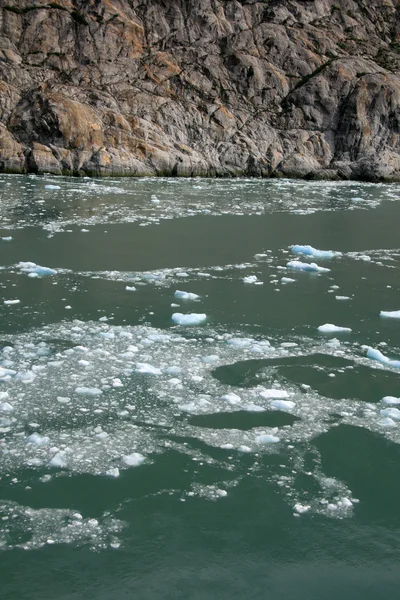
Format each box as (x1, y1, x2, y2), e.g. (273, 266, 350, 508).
(0, 0, 400, 181)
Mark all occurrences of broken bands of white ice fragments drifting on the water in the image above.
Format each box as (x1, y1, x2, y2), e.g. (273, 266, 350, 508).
(0, 176, 400, 550)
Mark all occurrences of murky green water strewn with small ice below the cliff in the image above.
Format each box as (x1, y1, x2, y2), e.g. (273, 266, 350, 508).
(0, 176, 400, 600)
